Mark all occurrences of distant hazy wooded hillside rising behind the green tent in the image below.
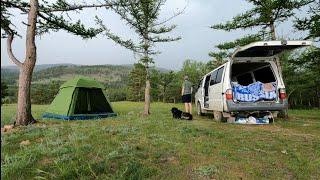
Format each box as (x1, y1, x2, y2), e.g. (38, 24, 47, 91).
(1, 64, 168, 86)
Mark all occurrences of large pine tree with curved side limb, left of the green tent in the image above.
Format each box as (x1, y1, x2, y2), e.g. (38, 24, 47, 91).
(1, 0, 115, 125)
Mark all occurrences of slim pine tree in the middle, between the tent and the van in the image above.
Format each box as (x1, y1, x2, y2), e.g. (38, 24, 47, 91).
(97, 0, 181, 115)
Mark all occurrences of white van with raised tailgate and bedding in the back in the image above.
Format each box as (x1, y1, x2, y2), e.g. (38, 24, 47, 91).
(195, 41, 311, 120)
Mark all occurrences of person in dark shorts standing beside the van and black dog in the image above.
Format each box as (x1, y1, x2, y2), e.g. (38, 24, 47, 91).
(181, 76, 192, 114)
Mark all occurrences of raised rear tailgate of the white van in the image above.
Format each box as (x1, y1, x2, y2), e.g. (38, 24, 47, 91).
(232, 41, 312, 59)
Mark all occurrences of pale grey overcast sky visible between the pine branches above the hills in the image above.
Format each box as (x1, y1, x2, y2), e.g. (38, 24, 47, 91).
(1, 0, 308, 70)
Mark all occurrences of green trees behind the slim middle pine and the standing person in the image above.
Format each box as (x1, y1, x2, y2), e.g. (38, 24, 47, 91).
(127, 60, 212, 102)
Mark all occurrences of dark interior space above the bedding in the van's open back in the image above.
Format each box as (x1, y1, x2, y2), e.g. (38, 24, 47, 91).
(231, 62, 276, 86)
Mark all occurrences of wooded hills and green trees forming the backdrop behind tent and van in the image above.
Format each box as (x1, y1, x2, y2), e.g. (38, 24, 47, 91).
(1, 48, 320, 108)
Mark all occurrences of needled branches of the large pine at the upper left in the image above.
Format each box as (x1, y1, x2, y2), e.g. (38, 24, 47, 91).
(1, 0, 114, 38)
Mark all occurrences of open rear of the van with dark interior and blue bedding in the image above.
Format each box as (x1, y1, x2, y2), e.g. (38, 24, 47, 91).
(231, 62, 277, 102)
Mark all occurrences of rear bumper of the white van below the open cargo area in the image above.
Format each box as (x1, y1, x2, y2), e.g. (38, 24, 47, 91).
(227, 100, 288, 112)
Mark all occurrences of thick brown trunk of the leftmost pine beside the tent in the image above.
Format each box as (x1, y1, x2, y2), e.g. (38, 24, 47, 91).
(16, 0, 39, 125)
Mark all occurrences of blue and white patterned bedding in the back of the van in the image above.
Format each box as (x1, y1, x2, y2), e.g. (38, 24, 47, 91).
(232, 81, 277, 102)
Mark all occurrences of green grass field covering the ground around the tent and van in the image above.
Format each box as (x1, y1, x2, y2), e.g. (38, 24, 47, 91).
(1, 102, 320, 179)
